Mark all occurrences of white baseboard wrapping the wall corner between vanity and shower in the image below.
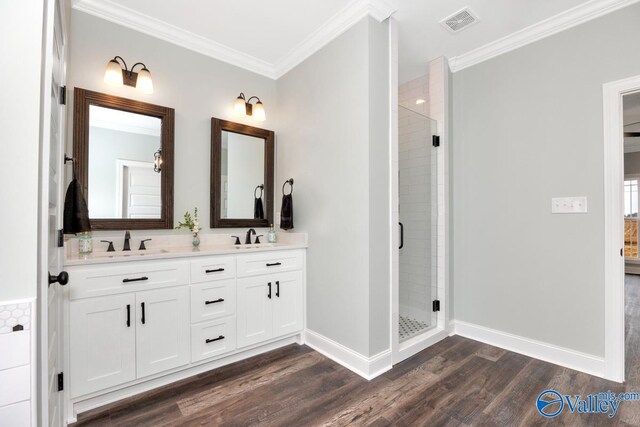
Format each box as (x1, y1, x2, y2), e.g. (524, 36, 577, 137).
(304, 329, 392, 380)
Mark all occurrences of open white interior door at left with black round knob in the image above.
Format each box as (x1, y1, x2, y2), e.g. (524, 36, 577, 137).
(38, 0, 66, 427)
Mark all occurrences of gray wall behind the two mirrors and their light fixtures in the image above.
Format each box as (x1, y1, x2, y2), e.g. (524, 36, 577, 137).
(67, 10, 277, 234)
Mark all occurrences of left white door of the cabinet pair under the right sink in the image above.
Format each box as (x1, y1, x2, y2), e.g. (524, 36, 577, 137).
(236, 276, 275, 347)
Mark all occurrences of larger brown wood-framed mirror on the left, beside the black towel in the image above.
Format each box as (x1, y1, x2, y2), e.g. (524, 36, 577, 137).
(73, 88, 175, 230)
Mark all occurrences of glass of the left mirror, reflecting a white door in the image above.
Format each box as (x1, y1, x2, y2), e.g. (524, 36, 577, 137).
(88, 105, 162, 219)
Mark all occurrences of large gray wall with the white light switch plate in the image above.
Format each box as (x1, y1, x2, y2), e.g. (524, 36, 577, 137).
(453, 5, 640, 356)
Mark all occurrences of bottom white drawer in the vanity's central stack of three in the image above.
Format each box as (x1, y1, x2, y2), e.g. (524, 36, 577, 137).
(191, 316, 236, 362)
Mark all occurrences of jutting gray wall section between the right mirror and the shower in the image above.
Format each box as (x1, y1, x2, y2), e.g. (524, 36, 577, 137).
(277, 18, 389, 355)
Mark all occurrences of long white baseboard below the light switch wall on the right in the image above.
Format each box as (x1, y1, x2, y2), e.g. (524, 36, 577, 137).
(452, 320, 605, 377)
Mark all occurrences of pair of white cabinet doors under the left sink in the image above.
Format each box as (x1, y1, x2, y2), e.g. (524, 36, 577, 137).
(69, 286, 189, 397)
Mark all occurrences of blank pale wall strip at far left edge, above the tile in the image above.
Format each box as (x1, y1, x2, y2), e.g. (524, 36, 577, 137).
(0, 0, 44, 301)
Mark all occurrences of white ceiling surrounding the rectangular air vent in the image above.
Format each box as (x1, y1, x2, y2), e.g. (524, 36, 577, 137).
(72, 0, 637, 82)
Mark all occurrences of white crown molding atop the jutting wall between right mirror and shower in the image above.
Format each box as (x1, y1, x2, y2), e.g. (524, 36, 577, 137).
(275, 0, 398, 78)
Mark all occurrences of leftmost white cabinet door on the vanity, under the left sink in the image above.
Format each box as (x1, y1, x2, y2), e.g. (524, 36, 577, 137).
(69, 294, 136, 397)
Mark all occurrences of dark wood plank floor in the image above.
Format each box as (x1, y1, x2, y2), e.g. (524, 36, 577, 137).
(76, 276, 640, 427)
